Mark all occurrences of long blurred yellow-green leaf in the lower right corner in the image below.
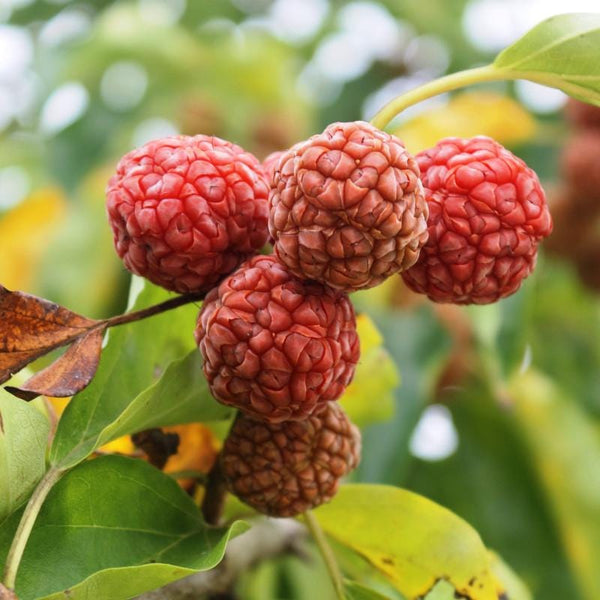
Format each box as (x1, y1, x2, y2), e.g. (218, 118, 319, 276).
(509, 371, 600, 600)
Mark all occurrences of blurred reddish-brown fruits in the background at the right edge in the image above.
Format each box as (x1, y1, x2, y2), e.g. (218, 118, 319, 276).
(549, 99, 600, 291)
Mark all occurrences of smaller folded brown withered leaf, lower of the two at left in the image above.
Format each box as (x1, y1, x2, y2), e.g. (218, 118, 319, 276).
(6, 326, 106, 400)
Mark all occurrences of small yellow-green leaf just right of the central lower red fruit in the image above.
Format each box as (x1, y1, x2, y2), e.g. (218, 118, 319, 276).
(340, 314, 400, 427)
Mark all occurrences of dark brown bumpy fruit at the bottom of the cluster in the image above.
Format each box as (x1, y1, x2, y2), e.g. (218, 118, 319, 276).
(221, 402, 360, 517)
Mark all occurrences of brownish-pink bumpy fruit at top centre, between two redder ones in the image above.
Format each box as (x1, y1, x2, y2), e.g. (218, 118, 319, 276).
(269, 121, 427, 291)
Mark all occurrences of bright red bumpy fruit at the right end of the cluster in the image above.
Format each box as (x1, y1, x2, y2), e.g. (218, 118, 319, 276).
(402, 136, 552, 304)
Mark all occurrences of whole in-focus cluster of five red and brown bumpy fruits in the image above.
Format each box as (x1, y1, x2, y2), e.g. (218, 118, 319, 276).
(107, 121, 552, 516)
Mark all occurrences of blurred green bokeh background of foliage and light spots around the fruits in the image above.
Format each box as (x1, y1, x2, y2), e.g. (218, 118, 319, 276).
(0, 0, 600, 600)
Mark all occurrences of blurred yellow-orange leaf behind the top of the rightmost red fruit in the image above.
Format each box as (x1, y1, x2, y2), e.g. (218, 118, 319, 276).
(394, 92, 535, 152)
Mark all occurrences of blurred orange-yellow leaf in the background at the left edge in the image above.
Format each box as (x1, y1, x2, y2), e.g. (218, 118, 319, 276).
(0, 187, 66, 290)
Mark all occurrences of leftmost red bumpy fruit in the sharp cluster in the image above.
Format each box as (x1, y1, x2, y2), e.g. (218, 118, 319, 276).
(107, 135, 269, 293)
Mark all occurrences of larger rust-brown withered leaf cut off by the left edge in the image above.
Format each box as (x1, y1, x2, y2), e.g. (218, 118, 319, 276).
(0, 285, 100, 383)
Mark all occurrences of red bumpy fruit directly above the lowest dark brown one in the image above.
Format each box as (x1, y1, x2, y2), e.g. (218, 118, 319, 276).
(195, 256, 359, 422)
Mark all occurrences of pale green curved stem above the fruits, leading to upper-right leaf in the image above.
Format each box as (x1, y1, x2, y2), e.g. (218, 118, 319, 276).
(371, 65, 506, 129)
